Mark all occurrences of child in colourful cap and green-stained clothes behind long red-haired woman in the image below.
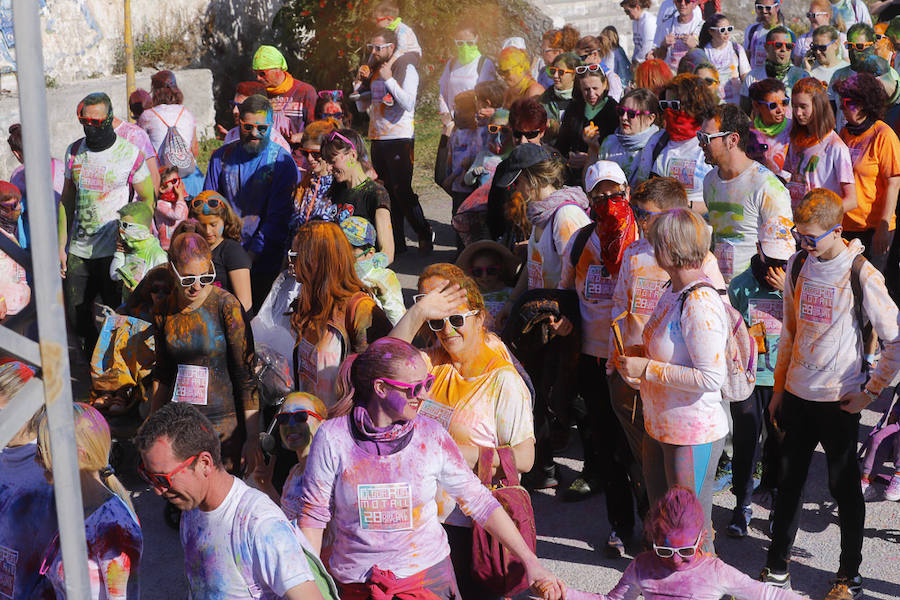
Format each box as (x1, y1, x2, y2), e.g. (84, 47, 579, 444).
(341, 217, 406, 325)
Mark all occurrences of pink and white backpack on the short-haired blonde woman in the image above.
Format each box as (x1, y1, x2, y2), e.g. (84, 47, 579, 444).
(679, 281, 757, 402)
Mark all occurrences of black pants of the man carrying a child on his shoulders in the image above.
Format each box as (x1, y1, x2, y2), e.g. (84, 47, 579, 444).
(372, 138, 431, 252)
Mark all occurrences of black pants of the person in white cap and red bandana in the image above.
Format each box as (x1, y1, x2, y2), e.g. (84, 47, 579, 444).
(572, 354, 635, 536)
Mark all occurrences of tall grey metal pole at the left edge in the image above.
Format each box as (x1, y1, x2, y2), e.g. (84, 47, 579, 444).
(12, 0, 91, 600)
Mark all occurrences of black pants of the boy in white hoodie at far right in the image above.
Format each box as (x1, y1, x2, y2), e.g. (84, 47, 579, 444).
(766, 392, 866, 577)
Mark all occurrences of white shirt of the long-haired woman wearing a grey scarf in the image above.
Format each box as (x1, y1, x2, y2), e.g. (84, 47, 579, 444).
(527, 204, 591, 290)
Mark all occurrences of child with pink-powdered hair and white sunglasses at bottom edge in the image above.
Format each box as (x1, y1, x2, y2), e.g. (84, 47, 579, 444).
(542, 485, 801, 600)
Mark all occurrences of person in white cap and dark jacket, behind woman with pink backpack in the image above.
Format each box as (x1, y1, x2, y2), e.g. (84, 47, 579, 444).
(727, 217, 797, 537)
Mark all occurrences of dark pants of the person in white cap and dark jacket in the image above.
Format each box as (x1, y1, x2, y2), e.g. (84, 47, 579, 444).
(729, 386, 779, 508)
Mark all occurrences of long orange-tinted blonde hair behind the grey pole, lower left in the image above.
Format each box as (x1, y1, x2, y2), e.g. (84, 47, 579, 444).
(37, 402, 137, 514)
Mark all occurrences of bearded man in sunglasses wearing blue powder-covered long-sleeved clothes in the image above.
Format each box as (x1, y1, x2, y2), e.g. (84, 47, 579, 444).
(203, 95, 298, 306)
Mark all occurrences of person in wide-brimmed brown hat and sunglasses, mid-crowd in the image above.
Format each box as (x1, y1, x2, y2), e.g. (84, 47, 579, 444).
(456, 240, 519, 333)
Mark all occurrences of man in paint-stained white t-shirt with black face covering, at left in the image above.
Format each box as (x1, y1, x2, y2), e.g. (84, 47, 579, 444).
(59, 93, 153, 355)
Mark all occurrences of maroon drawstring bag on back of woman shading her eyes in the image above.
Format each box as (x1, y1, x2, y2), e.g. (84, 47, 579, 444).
(472, 446, 537, 596)
